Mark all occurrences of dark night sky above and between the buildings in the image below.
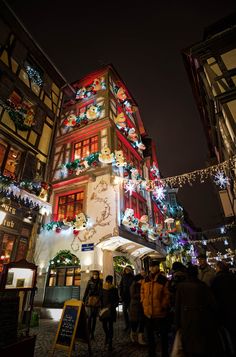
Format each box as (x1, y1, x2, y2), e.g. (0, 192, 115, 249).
(5, 0, 236, 229)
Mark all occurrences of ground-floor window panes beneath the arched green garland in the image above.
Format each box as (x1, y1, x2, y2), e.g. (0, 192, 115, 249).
(47, 267, 81, 287)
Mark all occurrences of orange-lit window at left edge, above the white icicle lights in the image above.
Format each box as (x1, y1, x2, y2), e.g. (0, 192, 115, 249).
(0, 139, 21, 179)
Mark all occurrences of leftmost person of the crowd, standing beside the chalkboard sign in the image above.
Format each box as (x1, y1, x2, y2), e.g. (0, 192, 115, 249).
(83, 270, 102, 340)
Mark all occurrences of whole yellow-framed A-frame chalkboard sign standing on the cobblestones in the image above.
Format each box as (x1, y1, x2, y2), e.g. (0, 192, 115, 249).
(53, 299, 90, 356)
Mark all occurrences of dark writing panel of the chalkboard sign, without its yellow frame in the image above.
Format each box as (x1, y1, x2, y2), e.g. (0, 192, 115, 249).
(56, 305, 79, 346)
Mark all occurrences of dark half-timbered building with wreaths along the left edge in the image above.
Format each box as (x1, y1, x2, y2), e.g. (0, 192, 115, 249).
(0, 1, 66, 271)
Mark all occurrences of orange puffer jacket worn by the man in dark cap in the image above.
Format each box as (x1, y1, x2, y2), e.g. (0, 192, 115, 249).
(141, 272, 170, 319)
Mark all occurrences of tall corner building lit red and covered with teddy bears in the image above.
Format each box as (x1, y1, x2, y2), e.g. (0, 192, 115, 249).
(36, 65, 182, 307)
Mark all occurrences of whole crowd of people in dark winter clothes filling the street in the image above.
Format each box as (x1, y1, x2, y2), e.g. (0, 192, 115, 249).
(83, 254, 236, 357)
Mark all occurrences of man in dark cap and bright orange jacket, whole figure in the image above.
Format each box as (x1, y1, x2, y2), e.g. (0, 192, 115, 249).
(141, 260, 170, 357)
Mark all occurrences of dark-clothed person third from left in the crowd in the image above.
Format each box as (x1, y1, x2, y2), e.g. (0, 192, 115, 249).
(120, 265, 134, 331)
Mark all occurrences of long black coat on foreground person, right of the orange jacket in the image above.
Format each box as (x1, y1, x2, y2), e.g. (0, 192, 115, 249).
(175, 279, 222, 357)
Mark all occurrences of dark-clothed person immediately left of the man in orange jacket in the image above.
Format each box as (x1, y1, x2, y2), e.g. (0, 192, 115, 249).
(130, 274, 146, 345)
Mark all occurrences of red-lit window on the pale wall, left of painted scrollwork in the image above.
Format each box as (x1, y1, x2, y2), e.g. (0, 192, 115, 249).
(57, 191, 84, 221)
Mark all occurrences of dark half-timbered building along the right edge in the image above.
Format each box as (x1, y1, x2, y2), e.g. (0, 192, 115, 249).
(183, 13, 236, 223)
